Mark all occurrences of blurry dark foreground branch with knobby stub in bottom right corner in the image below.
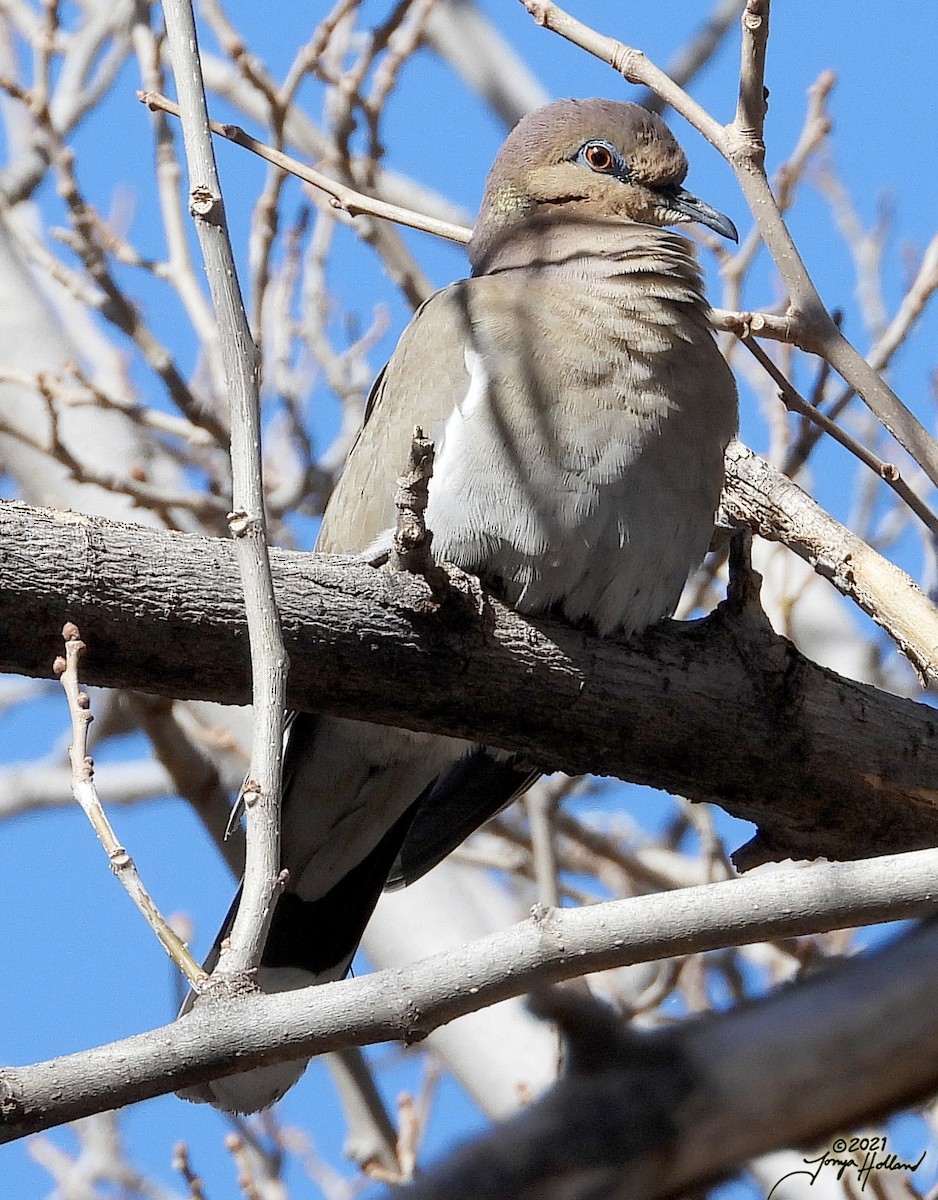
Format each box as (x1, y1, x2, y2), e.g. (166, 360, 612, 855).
(397, 920, 938, 1200)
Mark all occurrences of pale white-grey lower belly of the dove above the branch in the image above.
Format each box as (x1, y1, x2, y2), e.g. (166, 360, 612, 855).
(427, 338, 722, 634)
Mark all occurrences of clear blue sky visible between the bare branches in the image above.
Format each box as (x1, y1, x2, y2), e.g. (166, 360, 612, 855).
(0, 0, 938, 1200)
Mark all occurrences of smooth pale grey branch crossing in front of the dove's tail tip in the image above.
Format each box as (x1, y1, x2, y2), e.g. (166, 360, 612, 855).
(0, 851, 938, 1141)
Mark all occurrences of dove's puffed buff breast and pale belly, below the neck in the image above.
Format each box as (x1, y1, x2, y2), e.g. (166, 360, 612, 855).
(427, 266, 735, 632)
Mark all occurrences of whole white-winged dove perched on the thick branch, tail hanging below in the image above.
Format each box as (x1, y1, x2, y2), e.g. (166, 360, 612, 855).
(186, 100, 736, 1111)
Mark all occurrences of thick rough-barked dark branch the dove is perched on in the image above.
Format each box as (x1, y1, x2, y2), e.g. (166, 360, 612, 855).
(0, 504, 938, 865)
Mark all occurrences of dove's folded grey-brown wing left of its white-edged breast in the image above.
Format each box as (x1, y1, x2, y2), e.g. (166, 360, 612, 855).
(315, 280, 474, 554)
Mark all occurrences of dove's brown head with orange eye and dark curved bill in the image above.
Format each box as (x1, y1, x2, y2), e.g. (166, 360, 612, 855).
(469, 100, 738, 272)
